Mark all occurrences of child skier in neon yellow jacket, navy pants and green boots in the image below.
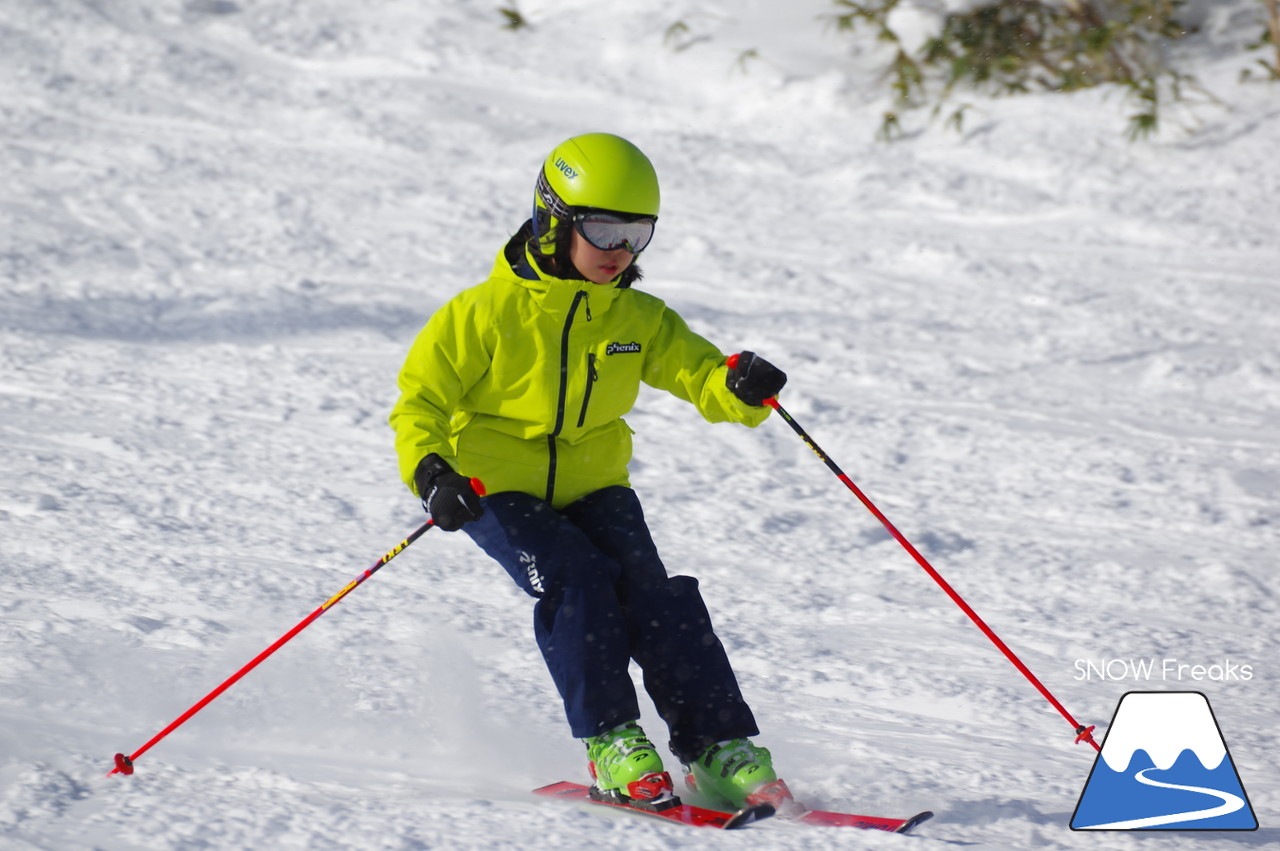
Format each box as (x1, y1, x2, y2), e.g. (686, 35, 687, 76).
(390, 133, 790, 807)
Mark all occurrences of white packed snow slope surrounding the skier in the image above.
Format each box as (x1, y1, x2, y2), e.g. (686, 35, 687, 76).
(0, 0, 1280, 850)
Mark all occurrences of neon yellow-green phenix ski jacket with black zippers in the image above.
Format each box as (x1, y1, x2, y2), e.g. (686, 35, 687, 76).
(390, 232, 771, 508)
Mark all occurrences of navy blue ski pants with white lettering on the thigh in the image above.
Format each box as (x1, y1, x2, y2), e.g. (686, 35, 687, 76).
(463, 488, 759, 763)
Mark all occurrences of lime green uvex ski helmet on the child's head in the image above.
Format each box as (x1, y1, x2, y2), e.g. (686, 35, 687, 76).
(532, 133, 660, 255)
